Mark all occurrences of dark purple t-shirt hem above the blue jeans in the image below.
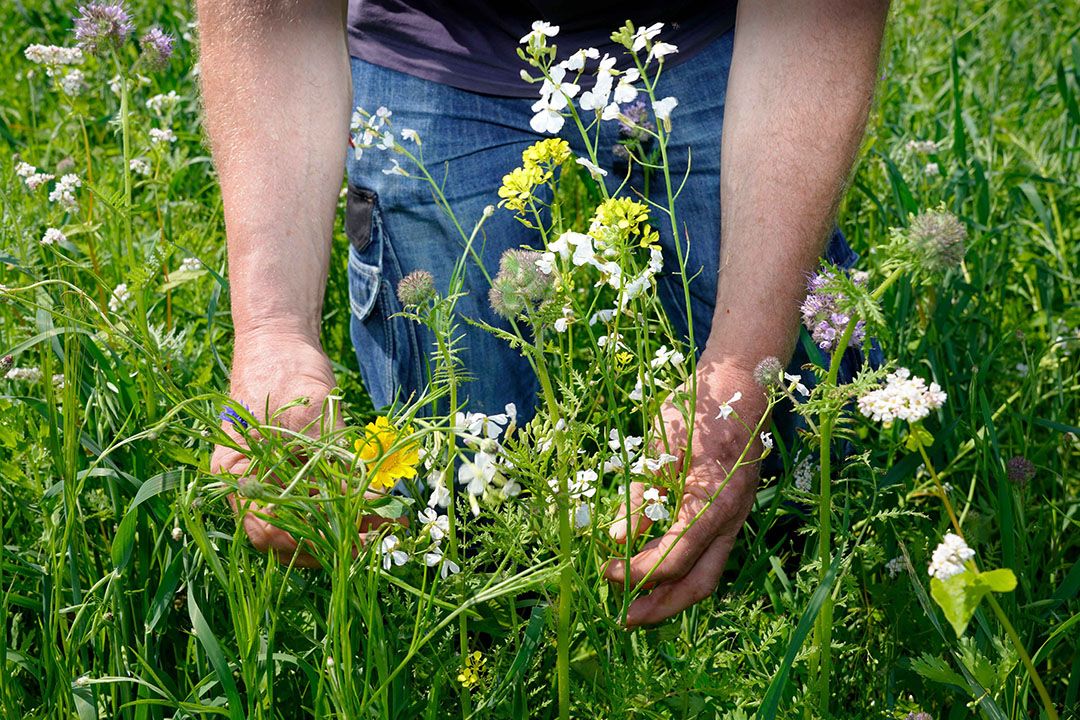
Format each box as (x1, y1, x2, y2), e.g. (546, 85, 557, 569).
(349, 0, 737, 97)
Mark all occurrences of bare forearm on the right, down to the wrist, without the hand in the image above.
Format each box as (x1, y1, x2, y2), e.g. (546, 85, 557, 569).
(703, 0, 888, 370)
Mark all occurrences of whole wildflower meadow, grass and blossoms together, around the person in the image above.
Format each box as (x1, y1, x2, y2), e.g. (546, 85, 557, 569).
(0, 0, 1080, 720)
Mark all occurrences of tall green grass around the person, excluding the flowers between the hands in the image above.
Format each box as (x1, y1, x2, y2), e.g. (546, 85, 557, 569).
(0, 1, 1080, 720)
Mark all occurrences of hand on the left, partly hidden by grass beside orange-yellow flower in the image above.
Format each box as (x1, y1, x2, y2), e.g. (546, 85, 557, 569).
(211, 330, 389, 568)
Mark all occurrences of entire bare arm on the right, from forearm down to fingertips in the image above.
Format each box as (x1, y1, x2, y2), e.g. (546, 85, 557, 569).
(607, 0, 888, 625)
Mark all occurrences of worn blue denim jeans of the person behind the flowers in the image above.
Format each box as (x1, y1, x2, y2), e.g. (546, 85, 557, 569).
(346, 31, 872, 439)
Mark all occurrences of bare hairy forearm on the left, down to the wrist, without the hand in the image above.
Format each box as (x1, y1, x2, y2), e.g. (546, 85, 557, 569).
(198, 0, 350, 343)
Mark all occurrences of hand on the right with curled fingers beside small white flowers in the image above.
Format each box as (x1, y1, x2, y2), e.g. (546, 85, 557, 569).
(605, 356, 767, 627)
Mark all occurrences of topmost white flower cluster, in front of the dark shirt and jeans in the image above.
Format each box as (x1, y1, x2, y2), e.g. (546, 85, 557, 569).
(521, 21, 678, 136)
